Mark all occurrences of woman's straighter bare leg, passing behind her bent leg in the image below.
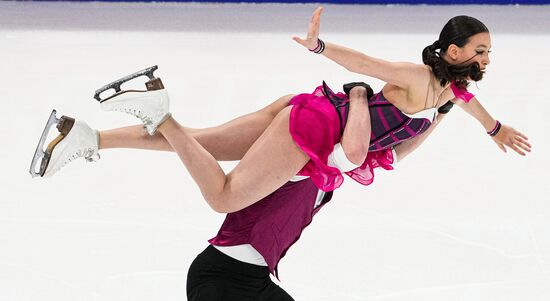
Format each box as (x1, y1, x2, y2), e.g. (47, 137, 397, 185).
(99, 95, 293, 161)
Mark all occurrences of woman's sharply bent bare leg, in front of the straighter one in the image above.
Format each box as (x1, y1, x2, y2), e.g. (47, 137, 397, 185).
(158, 107, 309, 212)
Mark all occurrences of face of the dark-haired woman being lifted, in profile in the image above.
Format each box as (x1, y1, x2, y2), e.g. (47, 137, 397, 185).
(445, 32, 491, 71)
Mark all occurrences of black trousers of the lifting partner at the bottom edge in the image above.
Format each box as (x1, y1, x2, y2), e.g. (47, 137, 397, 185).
(187, 245, 294, 301)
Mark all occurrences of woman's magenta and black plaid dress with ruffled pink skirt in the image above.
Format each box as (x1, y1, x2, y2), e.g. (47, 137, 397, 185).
(289, 83, 473, 191)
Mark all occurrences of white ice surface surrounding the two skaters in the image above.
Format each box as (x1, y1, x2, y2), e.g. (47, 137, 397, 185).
(0, 2, 550, 301)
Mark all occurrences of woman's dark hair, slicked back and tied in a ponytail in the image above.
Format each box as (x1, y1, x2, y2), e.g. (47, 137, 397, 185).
(422, 16, 489, 88)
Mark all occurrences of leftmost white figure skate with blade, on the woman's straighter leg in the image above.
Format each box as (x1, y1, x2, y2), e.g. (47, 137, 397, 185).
(30, 110, 99, 178)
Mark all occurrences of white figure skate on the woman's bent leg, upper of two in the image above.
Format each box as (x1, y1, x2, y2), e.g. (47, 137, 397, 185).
(94, 66, 170, 136)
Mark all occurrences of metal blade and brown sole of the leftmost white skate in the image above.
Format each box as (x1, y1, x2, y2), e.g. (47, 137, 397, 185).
(29, 110, 74, 178)
